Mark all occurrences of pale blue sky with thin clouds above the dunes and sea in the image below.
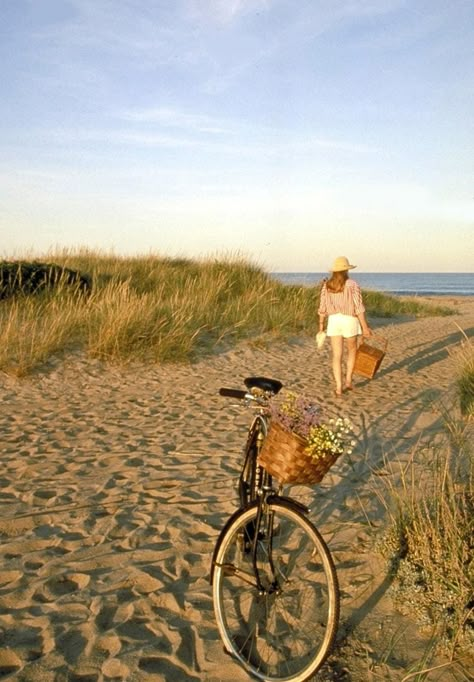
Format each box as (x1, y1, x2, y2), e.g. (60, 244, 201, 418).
(0, 0, 474, 272)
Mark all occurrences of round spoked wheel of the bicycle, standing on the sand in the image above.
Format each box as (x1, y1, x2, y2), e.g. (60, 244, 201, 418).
(213, 498, 340, 682)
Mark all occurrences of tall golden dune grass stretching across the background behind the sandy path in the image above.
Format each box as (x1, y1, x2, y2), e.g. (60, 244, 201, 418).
(0, 249, 456, 375)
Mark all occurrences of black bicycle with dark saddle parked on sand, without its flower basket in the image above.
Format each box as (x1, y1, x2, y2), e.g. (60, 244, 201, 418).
(210, 377, 340, 682)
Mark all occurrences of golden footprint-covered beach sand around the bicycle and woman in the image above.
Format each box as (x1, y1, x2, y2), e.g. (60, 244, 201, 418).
(0, 298, 474, 682)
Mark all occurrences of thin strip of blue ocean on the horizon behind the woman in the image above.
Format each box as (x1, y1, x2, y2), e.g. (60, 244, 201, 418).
(271, 271, 474, 296)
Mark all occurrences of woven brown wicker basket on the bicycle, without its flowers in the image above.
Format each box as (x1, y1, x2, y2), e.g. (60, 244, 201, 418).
(258, 423, 339, 485)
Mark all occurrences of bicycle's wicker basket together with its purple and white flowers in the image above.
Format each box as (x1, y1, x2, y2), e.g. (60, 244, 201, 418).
(259, 393, 355, 484)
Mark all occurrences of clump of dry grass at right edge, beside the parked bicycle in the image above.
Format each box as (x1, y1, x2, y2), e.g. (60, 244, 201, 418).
(381, 396, 474, 660)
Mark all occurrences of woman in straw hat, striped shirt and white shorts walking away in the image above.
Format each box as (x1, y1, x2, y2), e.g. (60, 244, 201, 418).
(318, 256, 372, 397)
